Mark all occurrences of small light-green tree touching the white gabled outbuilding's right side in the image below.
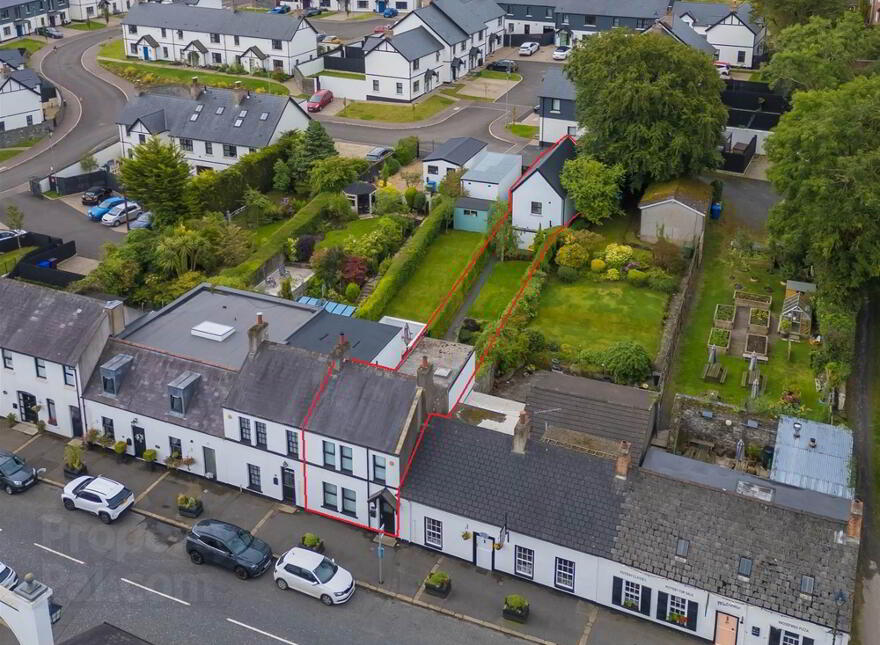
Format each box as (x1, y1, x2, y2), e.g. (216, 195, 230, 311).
(559, 154, 626, 224)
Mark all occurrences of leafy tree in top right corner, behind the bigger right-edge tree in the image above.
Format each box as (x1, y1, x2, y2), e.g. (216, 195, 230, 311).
(761, 12, 880, 94)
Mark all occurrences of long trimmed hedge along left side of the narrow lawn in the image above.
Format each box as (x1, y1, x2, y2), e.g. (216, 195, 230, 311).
(355, 196, 455, 320)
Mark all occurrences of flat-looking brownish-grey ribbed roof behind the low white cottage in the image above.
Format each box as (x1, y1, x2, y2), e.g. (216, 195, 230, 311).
(526, 372, 657, 461)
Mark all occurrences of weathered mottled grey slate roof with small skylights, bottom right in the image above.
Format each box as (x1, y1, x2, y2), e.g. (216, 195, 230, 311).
(612, 449, 858, 631)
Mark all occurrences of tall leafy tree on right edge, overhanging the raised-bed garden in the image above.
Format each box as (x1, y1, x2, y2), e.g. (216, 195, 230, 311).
(767, 76, 880, 298)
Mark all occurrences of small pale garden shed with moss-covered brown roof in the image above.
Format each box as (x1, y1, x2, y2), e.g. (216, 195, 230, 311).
(639, 177, 712, 246)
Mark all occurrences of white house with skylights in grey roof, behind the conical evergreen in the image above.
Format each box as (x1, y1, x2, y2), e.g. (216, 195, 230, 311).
(116, 78, 310, 172)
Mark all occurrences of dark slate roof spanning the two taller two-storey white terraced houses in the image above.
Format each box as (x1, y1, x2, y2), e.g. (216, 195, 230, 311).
(226, 343, 417, 454)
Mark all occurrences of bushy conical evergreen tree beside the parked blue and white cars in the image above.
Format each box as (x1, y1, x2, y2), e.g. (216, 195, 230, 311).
(121, 137, 190, 229)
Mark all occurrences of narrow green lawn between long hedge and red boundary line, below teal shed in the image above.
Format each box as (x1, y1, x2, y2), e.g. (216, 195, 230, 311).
(384, 231, 483, 322)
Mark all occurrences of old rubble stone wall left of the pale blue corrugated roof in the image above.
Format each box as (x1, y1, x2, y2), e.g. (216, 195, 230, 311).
(669, 394, 777, 457)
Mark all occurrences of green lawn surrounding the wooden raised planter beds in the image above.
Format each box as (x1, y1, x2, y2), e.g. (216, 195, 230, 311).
(672, 220, 825, 419)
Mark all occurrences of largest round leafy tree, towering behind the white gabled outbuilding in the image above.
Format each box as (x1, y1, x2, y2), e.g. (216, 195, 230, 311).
(566, 29, 727, 189)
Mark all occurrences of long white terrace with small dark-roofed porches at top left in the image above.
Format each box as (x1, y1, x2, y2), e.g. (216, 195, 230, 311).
(122, 2, 318, 74)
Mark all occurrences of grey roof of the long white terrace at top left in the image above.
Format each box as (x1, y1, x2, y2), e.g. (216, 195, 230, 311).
(122, 2, 308, 40)
